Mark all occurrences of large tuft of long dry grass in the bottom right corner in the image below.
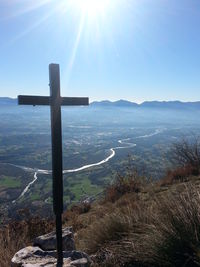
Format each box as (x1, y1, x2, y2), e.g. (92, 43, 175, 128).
(146, 184, 200, 267)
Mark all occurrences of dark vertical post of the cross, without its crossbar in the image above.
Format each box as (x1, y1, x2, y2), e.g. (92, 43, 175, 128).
(49, 64, 63, 267)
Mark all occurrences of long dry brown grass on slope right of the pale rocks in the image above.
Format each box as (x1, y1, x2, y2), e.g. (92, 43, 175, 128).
(79, 184, 200, 267)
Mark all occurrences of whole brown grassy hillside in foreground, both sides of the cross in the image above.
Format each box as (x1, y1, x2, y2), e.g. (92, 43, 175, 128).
(0, 156, 200, 267)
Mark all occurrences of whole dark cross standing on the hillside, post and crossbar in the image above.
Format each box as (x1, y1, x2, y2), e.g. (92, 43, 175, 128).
(18, 64, 89, 267)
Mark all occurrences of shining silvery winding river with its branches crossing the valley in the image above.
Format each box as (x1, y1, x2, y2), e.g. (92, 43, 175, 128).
(10, 129, 164, 203)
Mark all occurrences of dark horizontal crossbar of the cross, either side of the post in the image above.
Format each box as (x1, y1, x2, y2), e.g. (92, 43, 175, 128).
(18, 95, 89, 106)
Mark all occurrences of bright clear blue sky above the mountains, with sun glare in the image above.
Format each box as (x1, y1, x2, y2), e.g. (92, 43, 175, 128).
(0, 0, 200, 102)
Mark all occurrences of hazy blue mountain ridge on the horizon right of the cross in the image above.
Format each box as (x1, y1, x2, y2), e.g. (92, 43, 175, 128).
(90, 100, 200, 109)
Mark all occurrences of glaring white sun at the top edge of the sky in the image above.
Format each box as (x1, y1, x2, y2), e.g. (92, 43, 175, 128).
(65, 0, 110, 19)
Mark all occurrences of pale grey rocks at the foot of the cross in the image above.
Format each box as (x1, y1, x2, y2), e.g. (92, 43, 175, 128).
(11, 227, 91, 267)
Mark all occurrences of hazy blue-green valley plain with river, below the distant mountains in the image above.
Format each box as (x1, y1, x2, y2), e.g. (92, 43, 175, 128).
(0, 101, 200, 221)
